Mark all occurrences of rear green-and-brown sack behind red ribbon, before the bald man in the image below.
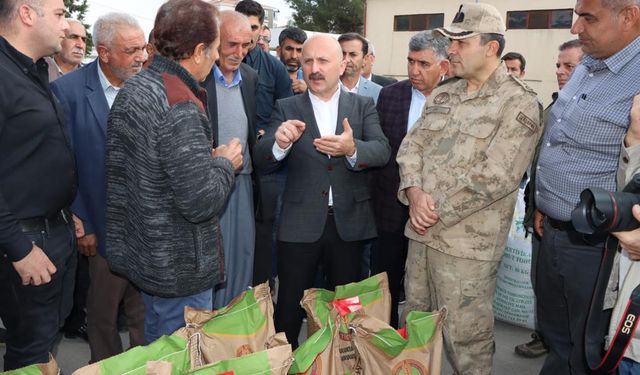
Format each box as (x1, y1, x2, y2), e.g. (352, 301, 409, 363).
(300, 272, 391, 335)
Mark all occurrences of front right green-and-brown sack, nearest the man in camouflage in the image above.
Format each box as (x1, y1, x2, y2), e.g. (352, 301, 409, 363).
(349, 310, 446, 375)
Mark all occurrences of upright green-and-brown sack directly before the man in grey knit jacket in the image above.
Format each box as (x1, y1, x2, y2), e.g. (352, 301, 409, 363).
(174, 283, 276, 370)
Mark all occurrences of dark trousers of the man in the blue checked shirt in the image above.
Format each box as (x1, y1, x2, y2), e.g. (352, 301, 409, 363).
(535, 220, 610, 375)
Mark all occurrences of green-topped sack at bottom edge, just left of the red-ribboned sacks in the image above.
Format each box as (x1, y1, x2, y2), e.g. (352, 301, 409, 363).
(186, 344, 293, 375)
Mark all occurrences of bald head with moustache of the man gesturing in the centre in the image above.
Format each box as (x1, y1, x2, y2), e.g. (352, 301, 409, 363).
(301, 35, 345, 101)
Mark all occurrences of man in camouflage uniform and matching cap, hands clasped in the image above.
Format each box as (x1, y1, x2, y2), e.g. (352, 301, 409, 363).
(397, 3, 542, 374)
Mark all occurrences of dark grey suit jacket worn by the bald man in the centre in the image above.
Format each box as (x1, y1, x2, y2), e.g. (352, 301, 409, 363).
(254, 91, 390, 243)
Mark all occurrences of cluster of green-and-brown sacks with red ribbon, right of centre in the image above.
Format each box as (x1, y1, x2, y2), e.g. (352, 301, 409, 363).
(289, 274, 444, 375)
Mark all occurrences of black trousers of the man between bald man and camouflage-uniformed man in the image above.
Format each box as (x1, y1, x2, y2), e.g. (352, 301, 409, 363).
(371, 232, 409, 328)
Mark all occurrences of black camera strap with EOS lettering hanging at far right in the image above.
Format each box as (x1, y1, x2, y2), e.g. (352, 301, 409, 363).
(585, 236, 640, 373)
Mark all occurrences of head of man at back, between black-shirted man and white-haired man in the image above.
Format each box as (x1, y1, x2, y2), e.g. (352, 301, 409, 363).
(45, 18, 87, 82)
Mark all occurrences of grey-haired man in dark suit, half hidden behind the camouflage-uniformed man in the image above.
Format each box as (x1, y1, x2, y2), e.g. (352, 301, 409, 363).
(371, 31, 449, 327)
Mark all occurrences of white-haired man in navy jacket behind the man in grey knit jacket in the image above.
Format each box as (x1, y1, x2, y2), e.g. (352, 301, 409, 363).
(52, 13, 146, 362)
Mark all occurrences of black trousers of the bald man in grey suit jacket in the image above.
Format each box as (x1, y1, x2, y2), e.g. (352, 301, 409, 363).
(275, 215, 364, 348)
